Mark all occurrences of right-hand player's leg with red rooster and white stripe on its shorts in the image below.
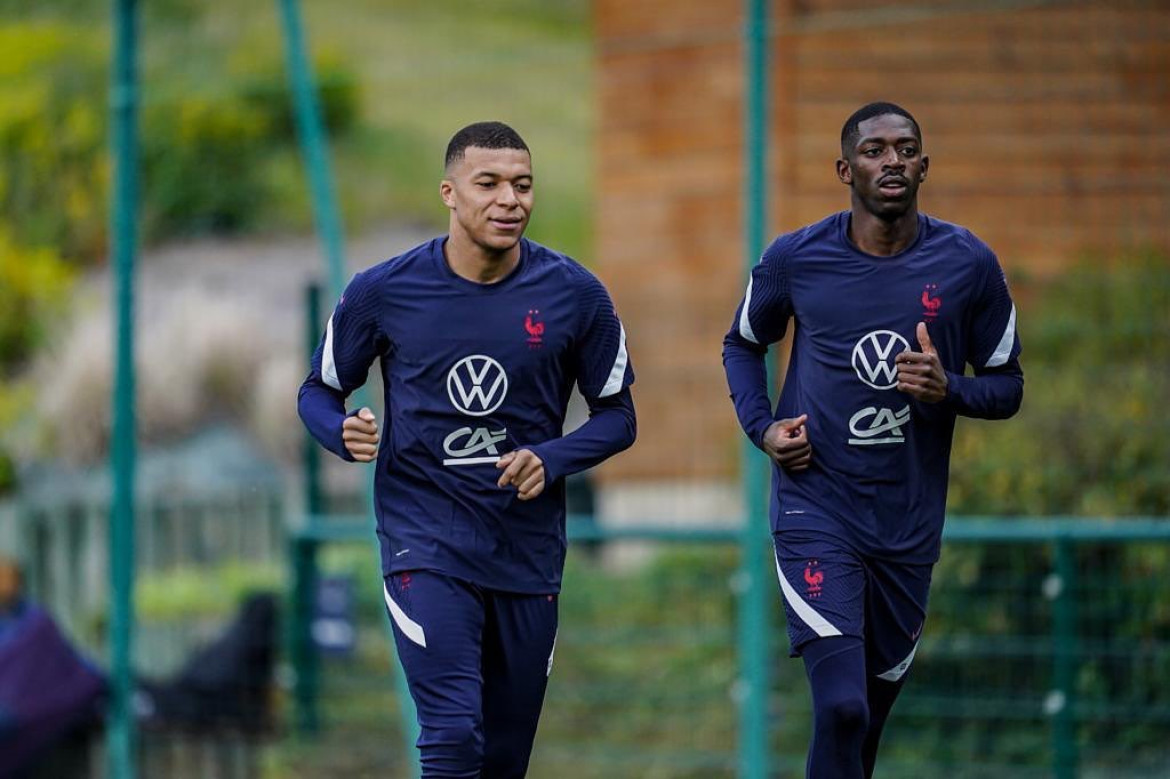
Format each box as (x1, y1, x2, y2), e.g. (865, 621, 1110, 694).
(775, 532, 869, 779)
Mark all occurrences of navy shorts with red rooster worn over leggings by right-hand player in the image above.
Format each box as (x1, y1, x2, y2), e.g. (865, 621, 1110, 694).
(772, 531, 934, 682)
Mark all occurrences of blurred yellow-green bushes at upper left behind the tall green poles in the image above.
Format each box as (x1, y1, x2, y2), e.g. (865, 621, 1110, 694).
(0, 22, 359, 250)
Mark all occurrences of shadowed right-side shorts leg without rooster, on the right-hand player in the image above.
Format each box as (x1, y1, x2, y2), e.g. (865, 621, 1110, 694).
(866, 560, 934, 682)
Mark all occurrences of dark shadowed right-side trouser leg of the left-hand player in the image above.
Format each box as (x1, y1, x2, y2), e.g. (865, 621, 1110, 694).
(483, 584, 558, 779)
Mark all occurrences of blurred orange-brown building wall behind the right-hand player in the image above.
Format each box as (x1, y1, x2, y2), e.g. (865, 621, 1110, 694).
(594, 0, 1170, 478)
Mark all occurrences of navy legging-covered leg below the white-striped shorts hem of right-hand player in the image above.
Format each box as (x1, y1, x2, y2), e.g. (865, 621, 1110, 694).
(800, 635, 869, 779)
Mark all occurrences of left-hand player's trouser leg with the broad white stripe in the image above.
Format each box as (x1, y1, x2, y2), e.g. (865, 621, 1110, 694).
(384, 571, 484, 779)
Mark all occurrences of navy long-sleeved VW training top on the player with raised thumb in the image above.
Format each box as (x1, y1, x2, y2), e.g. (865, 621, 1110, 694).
(723, 212, 1024, 563)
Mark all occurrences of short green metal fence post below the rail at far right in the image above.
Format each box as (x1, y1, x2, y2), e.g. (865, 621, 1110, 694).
(1045, 536, 1080, 779)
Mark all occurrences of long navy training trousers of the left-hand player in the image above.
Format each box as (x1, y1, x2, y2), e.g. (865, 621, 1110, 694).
(385, 571, 558, 779)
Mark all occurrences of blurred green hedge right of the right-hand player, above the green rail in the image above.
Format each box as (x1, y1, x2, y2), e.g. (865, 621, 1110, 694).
(949, 253, 1170, 516)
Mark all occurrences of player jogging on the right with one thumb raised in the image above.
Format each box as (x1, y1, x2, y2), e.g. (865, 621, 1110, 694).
(723, 103, 1024, 779)
